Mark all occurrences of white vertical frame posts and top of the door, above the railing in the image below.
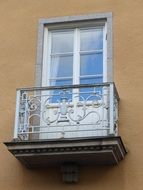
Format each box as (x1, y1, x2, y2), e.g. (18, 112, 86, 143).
(42, 22, 107, 86)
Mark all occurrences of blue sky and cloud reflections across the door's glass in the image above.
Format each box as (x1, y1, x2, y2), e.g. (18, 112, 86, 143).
(49, 27, 103, 102)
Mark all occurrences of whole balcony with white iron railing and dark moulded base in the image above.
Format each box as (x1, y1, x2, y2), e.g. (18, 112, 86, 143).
(5, 83, 126, 181)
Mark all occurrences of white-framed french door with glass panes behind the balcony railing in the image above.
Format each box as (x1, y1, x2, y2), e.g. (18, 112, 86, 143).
(40, 25, 107, 138)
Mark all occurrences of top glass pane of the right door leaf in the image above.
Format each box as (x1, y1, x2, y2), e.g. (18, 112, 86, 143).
(80, 29, 103, 51)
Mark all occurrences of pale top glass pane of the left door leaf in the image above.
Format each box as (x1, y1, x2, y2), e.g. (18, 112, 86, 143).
(52, 31, 73, 53)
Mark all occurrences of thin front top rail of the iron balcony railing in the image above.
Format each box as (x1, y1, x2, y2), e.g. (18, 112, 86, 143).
(16, 82, 115, 91)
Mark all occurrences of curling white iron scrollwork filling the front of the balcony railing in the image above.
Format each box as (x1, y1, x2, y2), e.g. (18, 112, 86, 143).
(19, 84, 118, 138)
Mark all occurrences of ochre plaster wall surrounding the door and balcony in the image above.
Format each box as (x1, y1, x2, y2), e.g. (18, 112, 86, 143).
(0, 0, 143, 190)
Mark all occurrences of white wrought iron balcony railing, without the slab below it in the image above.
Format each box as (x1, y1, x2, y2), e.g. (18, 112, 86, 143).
(14, 83, 119, 140)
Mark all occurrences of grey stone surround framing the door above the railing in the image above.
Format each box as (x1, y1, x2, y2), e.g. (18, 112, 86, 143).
(35, 12, 113, 87)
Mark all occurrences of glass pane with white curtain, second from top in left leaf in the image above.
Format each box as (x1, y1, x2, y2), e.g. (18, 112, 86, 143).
(50, 56, 73, 78)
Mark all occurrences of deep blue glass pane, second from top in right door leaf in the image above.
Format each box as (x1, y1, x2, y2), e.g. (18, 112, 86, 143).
(80, 53, 103, 76)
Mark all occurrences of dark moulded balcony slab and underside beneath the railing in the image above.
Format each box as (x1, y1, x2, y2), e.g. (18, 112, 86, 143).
(5, 137, 126, 168)
